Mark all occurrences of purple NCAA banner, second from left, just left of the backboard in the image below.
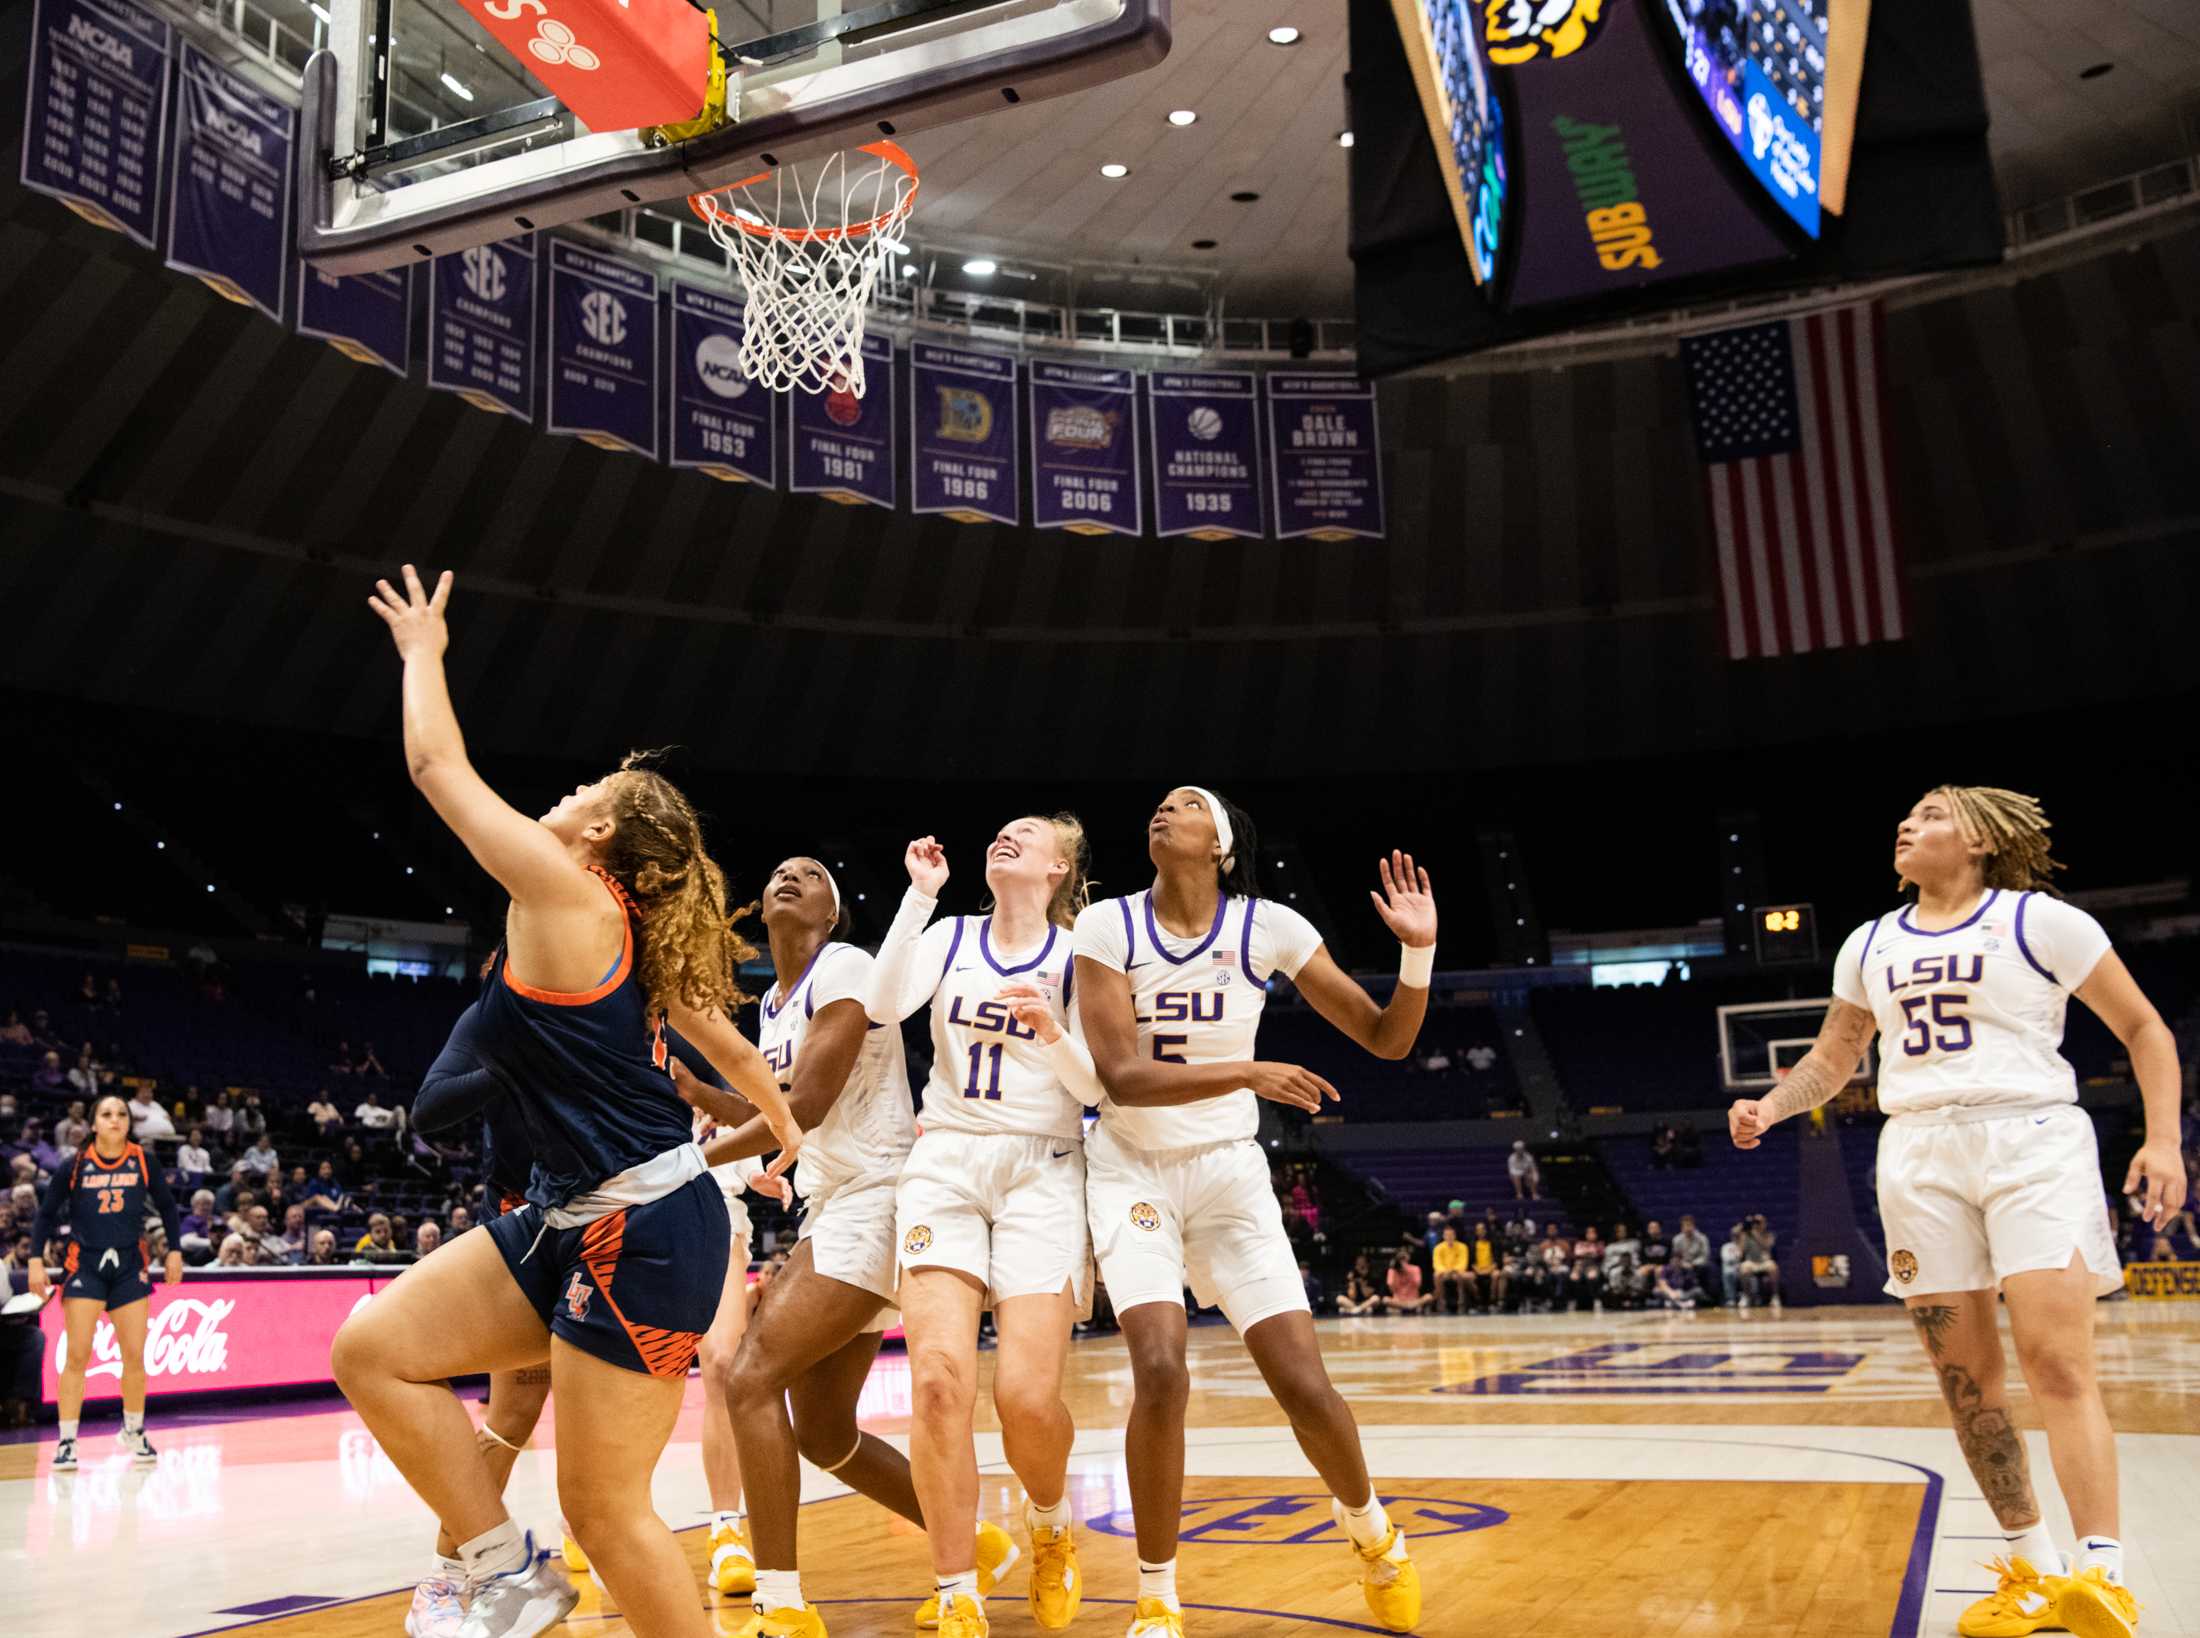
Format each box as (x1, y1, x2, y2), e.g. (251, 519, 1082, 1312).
(167, 40, 297, 323)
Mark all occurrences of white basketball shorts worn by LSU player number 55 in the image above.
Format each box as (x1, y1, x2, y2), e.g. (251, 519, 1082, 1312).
(1879, 1104, 2123, 1297)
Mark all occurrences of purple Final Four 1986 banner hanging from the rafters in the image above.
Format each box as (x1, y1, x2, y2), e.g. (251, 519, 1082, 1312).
(909, 341, 1023, 523)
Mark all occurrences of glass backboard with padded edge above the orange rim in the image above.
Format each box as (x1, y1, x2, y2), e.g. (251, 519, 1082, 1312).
(299, 0, 1170, 273)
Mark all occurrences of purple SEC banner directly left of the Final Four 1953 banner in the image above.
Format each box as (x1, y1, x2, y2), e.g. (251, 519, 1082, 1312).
(548, 240, 658, 460)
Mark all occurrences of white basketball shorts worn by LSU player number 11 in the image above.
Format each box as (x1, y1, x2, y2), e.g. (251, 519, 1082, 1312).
(893, 1130, 1091, 1308)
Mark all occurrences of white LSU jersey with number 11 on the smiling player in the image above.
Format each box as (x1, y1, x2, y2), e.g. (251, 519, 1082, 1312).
(871, 888, 1085, 1141)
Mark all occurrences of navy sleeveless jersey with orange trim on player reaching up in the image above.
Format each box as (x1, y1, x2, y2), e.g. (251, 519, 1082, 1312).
(471, 871, 689, 1207)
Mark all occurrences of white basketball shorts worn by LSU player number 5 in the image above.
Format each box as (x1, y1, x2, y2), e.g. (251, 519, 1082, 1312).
(1085, 1119, 1307, 1335)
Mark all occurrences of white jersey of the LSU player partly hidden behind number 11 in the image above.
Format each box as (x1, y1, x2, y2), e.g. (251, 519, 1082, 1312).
(757, 943, 917, 1196)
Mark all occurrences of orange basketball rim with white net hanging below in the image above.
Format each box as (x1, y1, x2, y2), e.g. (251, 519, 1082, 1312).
(689, 143, 917, 398)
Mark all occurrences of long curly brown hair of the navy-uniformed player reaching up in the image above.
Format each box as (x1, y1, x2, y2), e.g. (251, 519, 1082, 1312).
(601, 752, 757, 1016)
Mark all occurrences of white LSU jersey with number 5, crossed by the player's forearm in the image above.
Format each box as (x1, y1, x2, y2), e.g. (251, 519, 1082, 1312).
(1076, 893, 1322, 1150)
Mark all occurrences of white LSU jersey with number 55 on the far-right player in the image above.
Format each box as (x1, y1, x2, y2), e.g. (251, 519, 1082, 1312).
(1833, 888, 2108, 1115)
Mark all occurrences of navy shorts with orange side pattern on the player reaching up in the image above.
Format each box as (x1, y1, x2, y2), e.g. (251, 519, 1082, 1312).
(488, 1174, 730, 1376)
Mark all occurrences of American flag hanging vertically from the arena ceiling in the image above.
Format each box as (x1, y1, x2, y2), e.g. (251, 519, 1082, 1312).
(1681, 306, 1905, 660)
